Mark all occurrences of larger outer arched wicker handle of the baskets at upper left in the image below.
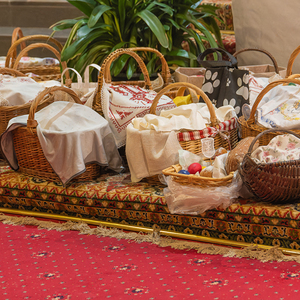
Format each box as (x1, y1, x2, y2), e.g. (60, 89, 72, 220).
(5, 35, 63, 68)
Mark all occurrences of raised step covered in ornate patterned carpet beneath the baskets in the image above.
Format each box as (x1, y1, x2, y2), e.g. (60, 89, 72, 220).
(0, 166, 300, 249)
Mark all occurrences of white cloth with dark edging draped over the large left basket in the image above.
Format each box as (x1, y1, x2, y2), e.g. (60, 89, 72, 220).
(1, 101, 122, 184)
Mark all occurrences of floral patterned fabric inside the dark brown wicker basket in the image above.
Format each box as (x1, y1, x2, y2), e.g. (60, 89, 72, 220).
(251, 134, 300, 163)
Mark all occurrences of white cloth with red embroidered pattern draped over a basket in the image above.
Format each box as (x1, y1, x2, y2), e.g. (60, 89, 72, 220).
(101, 83, 176, 147)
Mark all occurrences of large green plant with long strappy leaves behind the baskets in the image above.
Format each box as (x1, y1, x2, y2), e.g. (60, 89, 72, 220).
(52, 0, 222, 78)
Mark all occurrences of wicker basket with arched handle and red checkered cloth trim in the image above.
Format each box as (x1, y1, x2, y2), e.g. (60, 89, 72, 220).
(150, 82, 238, 154)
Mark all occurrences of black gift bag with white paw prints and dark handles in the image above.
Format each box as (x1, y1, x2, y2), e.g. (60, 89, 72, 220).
(197, 48, 249, 117)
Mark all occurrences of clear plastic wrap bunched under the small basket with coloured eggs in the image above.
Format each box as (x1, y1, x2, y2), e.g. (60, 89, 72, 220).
(164, 172, 243, 215)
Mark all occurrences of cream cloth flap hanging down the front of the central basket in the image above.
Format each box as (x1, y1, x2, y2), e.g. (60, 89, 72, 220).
(126, 124, 182, 182)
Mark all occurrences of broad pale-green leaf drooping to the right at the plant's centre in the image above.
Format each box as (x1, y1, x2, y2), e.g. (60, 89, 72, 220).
(137, 10, 169, 48)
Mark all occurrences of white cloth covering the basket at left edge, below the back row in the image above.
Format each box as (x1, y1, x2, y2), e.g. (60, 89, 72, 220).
(0, 74, 44, 106)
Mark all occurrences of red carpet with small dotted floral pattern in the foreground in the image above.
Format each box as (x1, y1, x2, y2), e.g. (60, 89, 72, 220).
(0, 219, 300, 300)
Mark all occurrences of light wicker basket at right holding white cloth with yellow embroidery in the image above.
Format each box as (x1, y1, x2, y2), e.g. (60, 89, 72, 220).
(238, 78, 300, 145)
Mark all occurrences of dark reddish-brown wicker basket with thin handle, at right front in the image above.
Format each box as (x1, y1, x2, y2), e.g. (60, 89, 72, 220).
(239, 129, 300, 203)
